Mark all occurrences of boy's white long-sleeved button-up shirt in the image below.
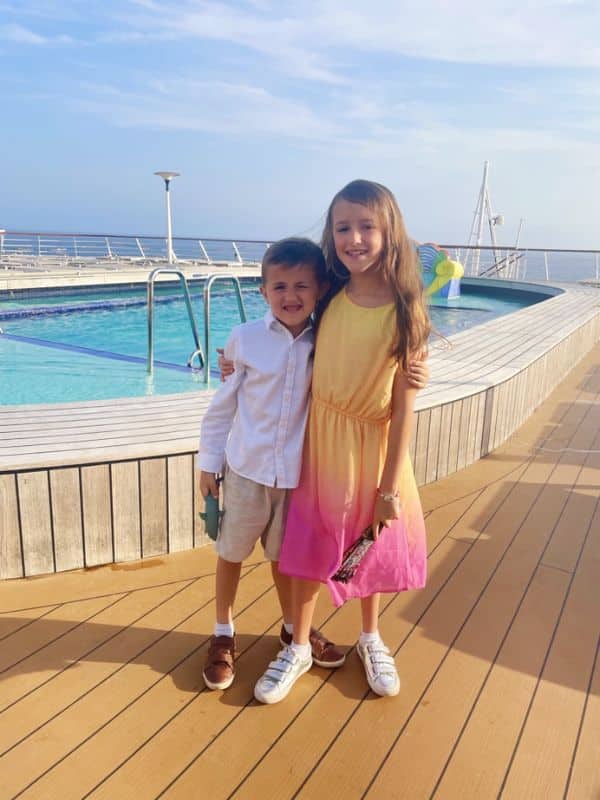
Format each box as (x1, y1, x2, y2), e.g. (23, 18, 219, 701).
(196, 310, 314, 489)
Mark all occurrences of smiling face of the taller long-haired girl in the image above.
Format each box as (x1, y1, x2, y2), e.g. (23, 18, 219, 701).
(331, 200, 383, 275)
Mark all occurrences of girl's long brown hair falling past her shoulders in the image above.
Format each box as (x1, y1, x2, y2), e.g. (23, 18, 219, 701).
(319, 180, 431, 370)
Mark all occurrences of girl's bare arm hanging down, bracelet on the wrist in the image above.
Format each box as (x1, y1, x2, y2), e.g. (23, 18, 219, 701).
(373, 367, 417, 538)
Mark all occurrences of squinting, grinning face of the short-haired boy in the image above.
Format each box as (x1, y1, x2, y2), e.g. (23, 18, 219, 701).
(260, 264, 324, 336)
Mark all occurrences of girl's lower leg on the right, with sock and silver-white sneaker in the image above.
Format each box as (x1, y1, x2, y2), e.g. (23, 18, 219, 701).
(356, 594, 400, 697)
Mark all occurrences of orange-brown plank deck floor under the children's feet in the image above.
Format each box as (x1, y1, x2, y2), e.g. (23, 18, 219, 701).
(0, 345, 600, 800)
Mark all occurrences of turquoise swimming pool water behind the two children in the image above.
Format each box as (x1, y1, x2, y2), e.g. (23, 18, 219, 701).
(0, 278, 547, 405)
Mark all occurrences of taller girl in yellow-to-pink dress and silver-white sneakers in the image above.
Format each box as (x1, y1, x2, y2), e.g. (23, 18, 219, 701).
(254, 180, 431, 703)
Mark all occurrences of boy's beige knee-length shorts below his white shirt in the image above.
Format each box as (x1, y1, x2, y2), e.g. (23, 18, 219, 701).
(215, 467, 288, 562)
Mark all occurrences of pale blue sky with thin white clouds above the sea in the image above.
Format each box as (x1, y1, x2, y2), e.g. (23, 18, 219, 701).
(0, 0, 600, 249)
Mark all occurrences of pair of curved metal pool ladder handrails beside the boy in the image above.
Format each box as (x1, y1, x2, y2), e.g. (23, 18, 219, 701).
(147, 267, 246, 383)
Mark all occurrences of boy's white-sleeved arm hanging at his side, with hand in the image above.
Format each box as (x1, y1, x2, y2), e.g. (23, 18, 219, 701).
(196, 332, 245, 482)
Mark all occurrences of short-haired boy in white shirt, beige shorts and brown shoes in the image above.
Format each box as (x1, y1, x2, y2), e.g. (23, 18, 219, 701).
(197, 238, 345, 689)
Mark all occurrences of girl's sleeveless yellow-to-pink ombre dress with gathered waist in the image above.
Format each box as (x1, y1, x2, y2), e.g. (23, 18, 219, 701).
(279, 289, 427, 605)
